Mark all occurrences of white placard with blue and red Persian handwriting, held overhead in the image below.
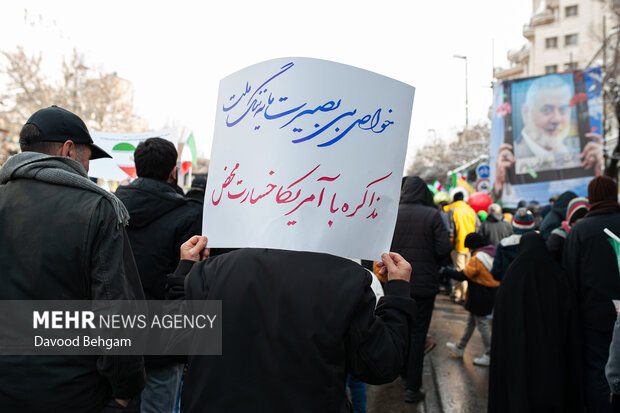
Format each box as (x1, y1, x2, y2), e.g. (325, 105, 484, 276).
(203, 58, 414, 260)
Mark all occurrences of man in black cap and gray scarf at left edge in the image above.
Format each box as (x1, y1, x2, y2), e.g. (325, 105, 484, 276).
(0, 106, 144, 412)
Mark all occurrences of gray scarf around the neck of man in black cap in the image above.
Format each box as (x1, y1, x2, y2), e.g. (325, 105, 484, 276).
(0, 152, 129, 226)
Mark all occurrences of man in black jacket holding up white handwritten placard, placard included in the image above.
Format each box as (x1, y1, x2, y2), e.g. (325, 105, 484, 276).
(168, 58, 415, 413)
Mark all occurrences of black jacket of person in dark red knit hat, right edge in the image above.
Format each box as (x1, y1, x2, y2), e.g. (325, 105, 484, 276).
(562, 210, 620, 333)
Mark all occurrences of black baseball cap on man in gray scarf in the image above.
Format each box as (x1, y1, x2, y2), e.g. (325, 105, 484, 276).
(26, 105, 111, 159)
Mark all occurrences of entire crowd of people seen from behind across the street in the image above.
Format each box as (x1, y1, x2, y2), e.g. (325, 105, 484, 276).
(0, 106, 620, 413)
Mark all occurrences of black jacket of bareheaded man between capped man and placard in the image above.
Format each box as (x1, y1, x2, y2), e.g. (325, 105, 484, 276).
(116, 178, 202, 300)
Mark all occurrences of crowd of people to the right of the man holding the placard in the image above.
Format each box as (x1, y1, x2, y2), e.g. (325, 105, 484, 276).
(392, 172, 620, 412)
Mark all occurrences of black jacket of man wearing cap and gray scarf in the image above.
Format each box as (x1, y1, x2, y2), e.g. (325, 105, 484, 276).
(0, 171, 144, 412)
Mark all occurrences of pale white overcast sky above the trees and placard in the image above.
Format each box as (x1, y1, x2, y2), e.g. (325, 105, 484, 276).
(0, 0, 532, 167)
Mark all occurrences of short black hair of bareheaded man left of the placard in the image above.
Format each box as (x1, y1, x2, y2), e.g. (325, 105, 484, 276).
(133, 138, 177, 181)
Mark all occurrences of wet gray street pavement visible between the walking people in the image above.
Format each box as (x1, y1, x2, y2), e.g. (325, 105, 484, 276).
(367, 294, 489, 413)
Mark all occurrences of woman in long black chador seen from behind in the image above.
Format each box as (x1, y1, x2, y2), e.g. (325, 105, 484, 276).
(488, 232, 584, 413)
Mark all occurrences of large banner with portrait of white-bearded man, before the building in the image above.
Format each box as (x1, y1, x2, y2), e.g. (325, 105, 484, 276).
(490, 68, 602, 207)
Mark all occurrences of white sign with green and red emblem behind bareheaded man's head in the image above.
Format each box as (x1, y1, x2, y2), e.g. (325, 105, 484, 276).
(88, 129, 178, 181)
